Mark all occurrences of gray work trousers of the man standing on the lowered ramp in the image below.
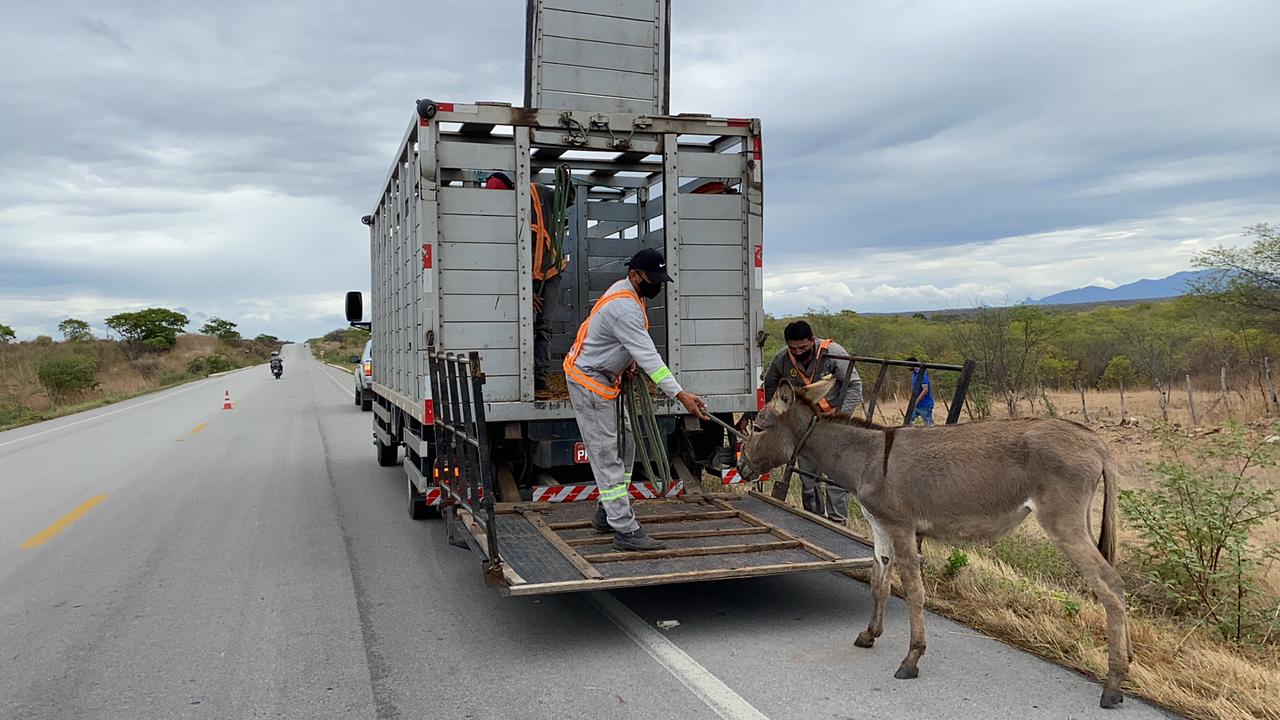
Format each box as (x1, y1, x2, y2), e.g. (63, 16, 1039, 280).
(568, 379, 640, 533)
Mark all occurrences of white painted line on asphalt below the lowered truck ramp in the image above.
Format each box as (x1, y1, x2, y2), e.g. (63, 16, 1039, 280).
(584, 592, 769, 720)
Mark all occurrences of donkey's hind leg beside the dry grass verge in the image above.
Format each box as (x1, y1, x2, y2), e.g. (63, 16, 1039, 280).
(1039, 509, 1133, 707)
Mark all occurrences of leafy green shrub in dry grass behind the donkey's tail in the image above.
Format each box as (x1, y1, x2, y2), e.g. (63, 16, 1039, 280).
(1120, 424, 1280, 643)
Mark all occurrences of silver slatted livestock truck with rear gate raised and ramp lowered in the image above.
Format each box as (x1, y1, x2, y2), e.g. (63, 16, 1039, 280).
(347, 0, 870, 596)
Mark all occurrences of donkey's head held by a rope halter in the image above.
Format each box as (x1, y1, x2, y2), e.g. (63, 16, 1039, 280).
(737, 380, 835, 480)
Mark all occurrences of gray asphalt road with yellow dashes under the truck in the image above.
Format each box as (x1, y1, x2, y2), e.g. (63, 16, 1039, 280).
(0, 346, 1165, 720)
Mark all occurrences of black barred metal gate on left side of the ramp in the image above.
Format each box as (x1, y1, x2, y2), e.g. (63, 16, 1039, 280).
(426, 347, 502, 580)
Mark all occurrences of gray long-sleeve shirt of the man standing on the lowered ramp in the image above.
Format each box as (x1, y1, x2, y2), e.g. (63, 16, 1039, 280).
(564, 278, 681, 398)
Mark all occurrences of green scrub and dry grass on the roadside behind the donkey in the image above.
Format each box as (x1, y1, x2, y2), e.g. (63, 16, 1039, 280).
(747, 224, 1280, 719)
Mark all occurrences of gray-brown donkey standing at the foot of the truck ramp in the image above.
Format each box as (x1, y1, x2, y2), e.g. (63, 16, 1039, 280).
(739, 380, 1133, 707)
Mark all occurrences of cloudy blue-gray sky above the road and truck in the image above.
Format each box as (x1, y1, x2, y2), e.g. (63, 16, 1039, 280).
(0, 0, 1280, 338)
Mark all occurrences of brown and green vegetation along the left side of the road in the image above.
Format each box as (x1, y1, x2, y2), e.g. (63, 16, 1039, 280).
(0, 307, 280, 430)
